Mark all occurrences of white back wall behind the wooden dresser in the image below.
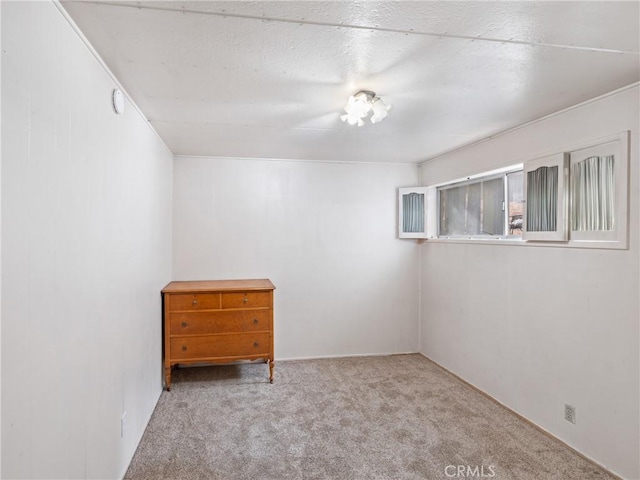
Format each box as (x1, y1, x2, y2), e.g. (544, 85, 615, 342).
(173, 157, 419, 360)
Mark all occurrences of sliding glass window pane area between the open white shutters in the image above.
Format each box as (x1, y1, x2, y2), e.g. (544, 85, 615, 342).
(437, 167, 522, 238)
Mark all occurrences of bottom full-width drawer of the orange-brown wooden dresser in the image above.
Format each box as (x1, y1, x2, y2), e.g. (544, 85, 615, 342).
(171, 332, 271, 360)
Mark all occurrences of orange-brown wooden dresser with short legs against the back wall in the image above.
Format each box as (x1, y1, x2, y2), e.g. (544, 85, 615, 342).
(162, 279, 275, 390)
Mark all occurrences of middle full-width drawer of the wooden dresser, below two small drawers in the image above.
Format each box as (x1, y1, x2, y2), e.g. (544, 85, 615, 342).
(171, 310, 272, 335)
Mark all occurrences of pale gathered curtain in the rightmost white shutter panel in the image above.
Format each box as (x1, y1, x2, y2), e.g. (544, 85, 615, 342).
(571, 155, 615, 231)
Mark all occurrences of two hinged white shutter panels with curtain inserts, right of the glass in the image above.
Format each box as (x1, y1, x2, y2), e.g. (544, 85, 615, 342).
(523, 132, 629, 248)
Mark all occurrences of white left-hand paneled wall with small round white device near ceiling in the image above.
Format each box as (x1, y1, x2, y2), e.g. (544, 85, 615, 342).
(1, 2, 173, 479)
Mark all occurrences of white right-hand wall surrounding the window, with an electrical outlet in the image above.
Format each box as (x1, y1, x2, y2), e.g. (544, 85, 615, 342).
(421, 86, 640, 479)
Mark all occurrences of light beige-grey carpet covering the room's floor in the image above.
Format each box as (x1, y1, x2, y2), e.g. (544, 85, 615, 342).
(125, 355, 615, 480)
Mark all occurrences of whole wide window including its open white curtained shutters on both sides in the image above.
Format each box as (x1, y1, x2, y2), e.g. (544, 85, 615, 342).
(398, 132, 629, 249)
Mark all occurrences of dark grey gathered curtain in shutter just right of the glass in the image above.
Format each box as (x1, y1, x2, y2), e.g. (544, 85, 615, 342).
(526, 166, 558, 232)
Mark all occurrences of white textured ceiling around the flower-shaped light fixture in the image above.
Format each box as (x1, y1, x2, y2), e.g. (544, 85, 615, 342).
(62, 1, 640, 163)
